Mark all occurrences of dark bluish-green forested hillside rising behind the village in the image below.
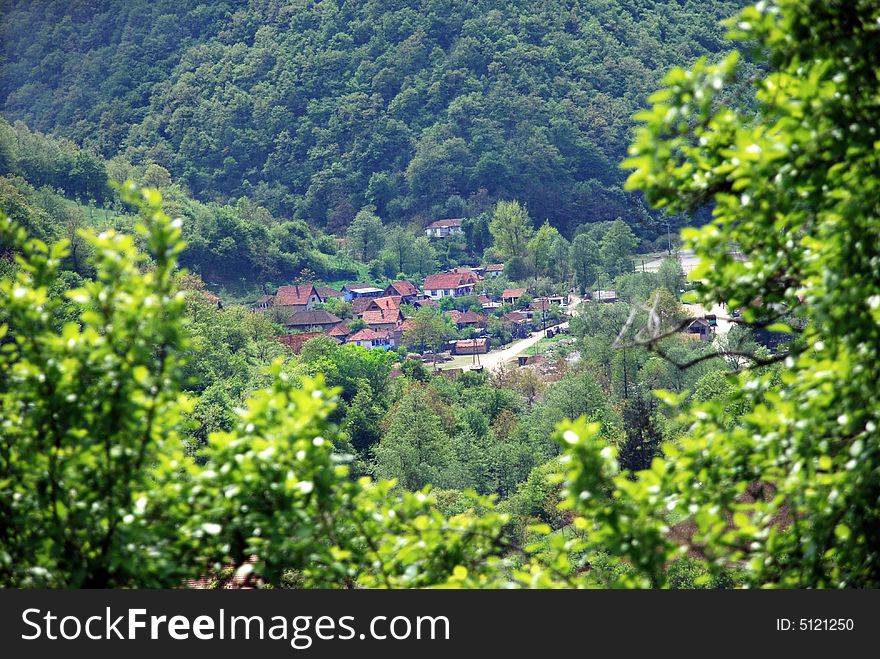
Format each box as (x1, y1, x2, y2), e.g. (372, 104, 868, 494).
(0, 0, 743, 236)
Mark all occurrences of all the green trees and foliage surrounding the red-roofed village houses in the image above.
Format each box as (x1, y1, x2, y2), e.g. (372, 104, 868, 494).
(0, 0, 880, 588)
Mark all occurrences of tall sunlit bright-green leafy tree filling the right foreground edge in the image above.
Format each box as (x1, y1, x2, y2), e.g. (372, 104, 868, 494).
(566, 0, 880, 588)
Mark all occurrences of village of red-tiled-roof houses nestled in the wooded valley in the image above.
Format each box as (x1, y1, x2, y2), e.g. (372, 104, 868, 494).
(232, 219, 726, 377)
